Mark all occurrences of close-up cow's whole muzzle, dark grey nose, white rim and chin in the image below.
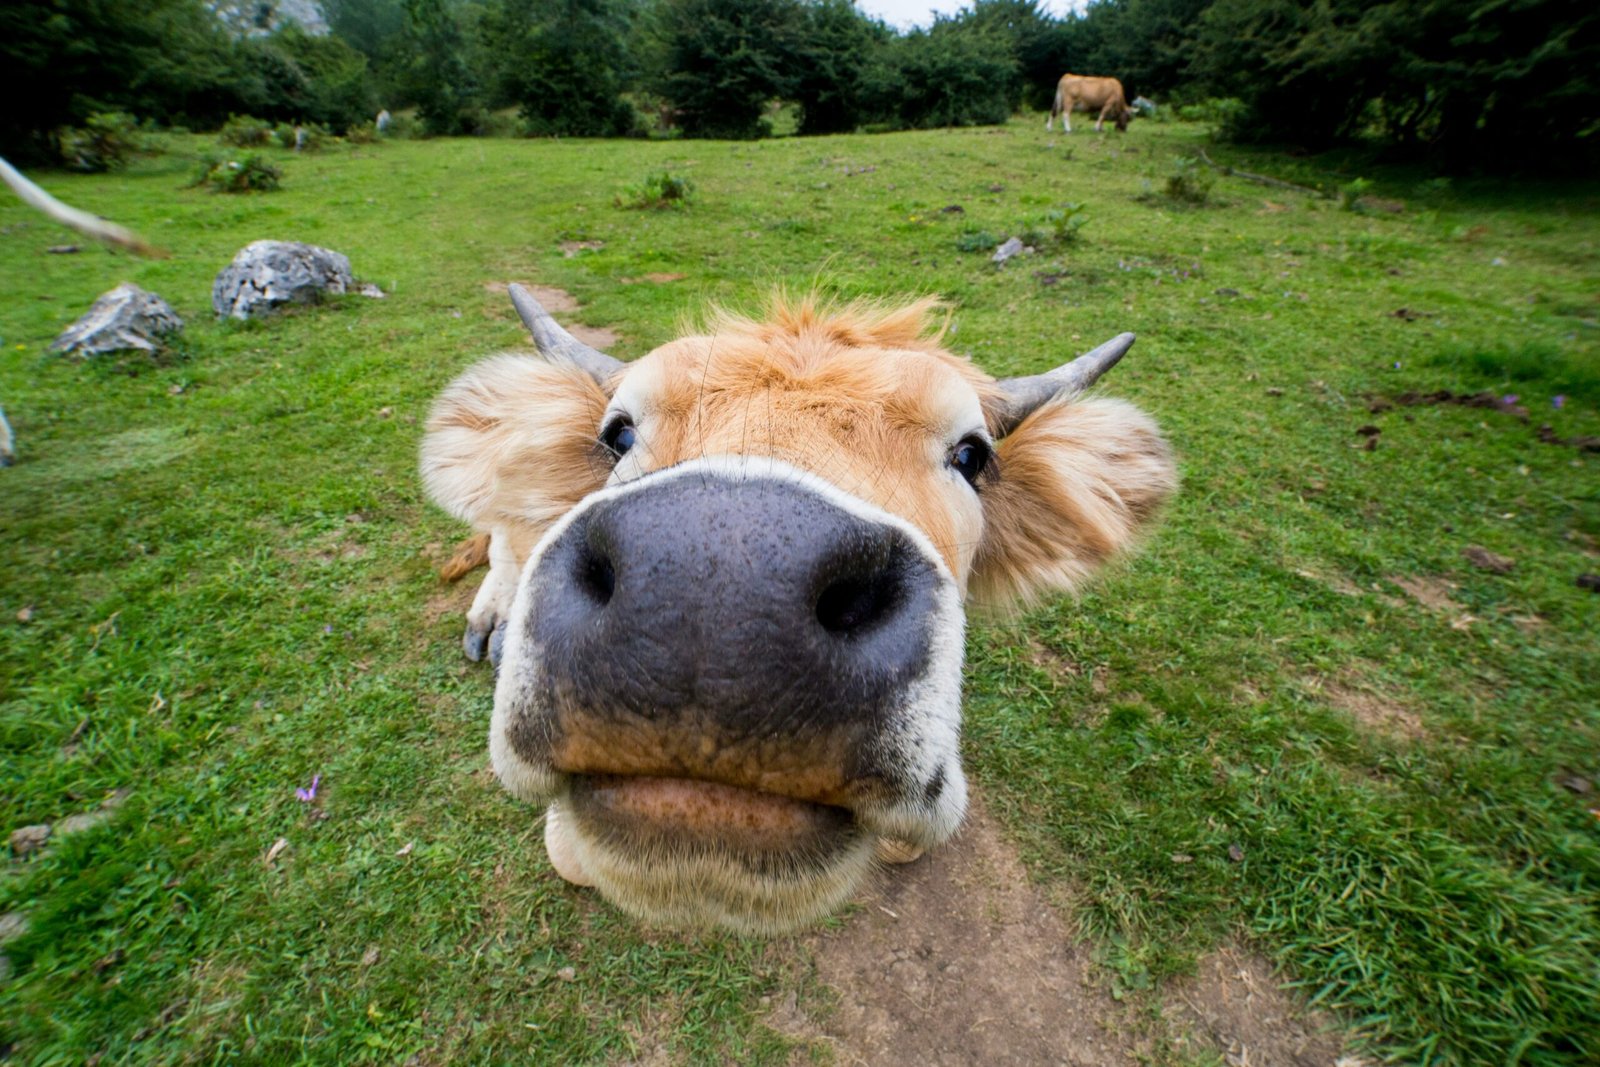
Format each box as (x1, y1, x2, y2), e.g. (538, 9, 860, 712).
(490, 458, 966, 931)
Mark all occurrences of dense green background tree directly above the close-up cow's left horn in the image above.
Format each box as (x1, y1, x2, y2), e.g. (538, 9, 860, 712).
(483, 0, 634, 138)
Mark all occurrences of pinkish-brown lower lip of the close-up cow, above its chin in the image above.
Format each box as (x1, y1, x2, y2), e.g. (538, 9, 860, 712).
(573, 774, 854, 849)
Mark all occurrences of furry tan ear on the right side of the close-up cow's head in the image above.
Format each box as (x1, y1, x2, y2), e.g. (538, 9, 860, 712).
(968, 398, 1178, 609)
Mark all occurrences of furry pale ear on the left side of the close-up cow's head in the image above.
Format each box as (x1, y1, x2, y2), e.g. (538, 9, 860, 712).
(422, 355, 611, 536)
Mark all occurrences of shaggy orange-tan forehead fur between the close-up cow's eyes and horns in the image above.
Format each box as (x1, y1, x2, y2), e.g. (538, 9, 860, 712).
(611, 298, 995, 574)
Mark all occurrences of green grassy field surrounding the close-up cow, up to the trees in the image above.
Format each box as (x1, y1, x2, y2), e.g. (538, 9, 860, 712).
(0, 118, 1600, 1065)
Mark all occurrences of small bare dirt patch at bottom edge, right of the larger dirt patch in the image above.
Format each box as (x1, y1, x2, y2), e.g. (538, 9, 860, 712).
(1166, 945, 1360, 1067)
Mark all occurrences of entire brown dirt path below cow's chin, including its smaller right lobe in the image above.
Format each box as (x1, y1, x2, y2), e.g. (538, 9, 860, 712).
(768, 808, 1360, 1067)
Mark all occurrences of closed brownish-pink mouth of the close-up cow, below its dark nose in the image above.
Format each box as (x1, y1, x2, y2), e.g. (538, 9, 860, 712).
(568, 774, 859, 857)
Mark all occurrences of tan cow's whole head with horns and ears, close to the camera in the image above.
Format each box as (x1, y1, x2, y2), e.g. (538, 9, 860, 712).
(422, 286, 1176, 933)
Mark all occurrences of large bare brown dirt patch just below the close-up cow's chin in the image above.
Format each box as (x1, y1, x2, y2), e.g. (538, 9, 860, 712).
(770, 809, 1133, 1067)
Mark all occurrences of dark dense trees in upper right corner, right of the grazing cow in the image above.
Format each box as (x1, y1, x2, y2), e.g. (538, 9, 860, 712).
(1190, 0, 1600, 170)
